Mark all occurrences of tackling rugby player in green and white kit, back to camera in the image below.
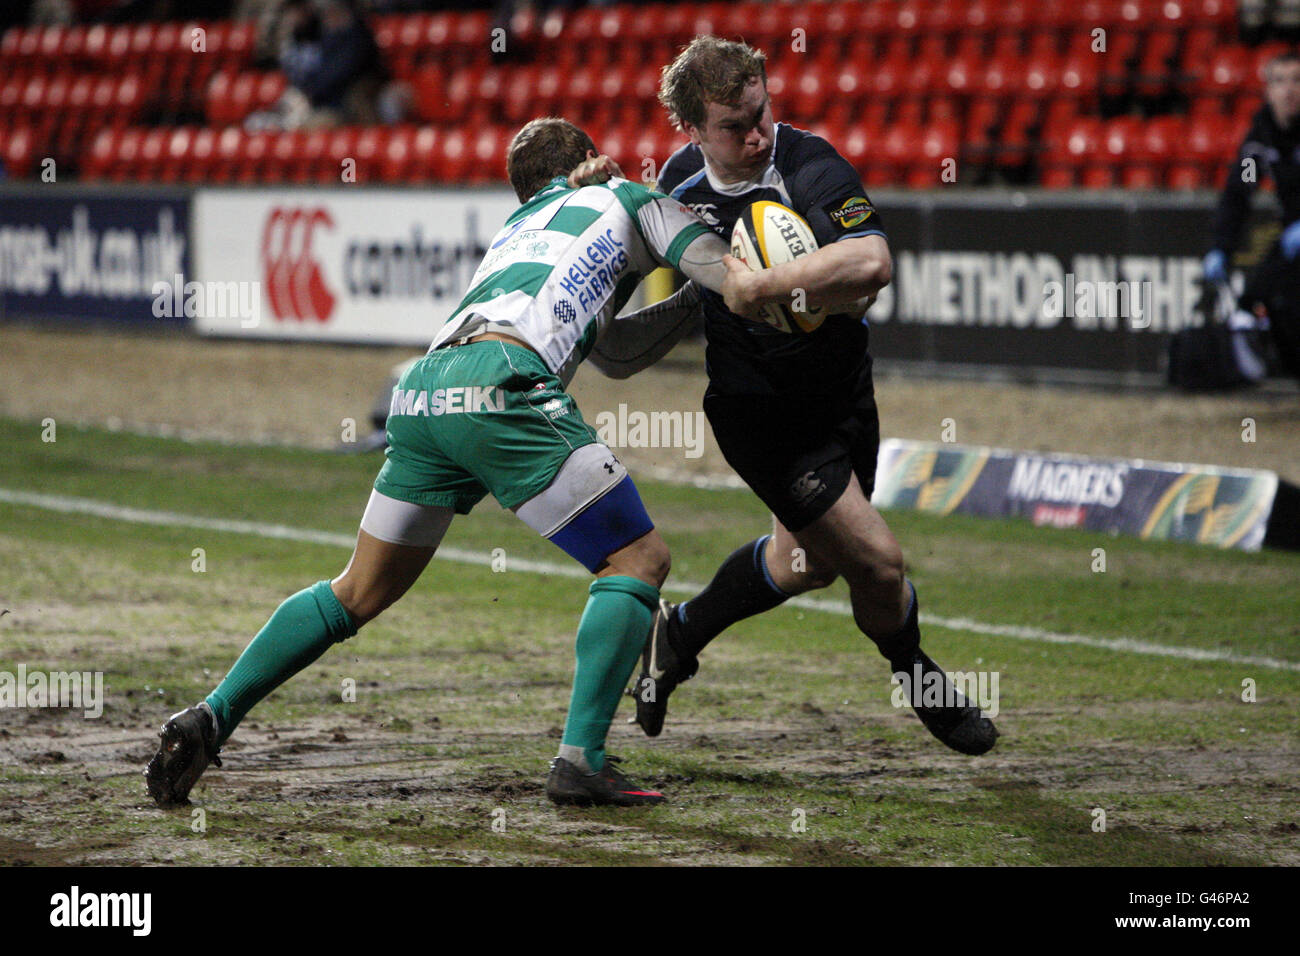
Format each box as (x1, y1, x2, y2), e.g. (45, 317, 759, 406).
(146, 118, 832, 806)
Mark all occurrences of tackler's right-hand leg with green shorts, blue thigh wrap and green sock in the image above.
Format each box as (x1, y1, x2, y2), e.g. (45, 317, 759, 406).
(452, 342, 668, 804)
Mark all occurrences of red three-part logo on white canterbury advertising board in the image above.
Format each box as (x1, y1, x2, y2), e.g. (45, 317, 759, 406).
(261, 206, 335, 323)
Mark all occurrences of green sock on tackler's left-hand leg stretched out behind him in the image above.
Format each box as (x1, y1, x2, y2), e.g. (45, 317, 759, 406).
(208, 581, 356, 745)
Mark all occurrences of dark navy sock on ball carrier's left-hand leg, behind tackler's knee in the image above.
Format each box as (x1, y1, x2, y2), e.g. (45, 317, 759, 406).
(668, 535, 789, 658)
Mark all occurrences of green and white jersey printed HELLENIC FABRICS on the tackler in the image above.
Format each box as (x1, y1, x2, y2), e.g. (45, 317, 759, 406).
(429, 177, 711, 385)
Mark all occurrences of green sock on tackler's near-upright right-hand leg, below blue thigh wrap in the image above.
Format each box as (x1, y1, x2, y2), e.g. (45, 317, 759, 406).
(563, 575, 659, 770)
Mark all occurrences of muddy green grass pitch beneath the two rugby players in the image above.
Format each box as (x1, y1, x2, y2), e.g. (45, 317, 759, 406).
(0, 419, 1300, 865)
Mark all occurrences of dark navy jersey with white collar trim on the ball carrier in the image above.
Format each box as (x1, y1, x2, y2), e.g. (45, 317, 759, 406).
(658, 122, 885, 394)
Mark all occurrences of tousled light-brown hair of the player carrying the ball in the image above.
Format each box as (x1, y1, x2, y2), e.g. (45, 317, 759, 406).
(659, 36, 767, 129)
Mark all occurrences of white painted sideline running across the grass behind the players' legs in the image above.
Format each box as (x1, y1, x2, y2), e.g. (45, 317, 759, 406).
(0, 488, 1300, 672)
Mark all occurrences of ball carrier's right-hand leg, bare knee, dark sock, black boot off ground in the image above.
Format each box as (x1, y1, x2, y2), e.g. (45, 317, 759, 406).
(796, 475, 997, 756)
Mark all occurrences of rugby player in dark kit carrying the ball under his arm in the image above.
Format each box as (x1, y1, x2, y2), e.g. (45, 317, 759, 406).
(593, 36, 997, 754)
